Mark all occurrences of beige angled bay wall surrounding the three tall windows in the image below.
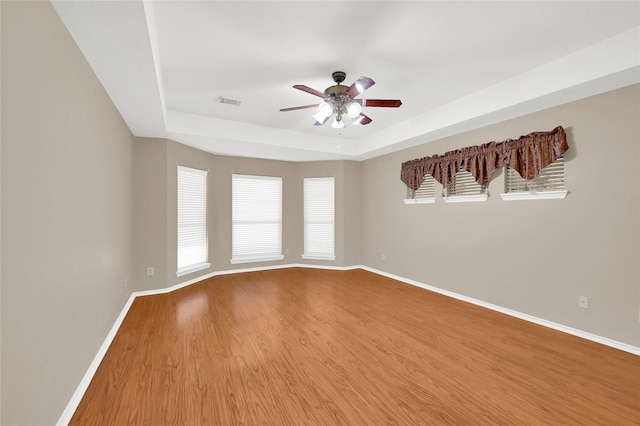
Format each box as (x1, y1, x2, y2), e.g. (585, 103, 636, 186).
(134, 138, 361, 290)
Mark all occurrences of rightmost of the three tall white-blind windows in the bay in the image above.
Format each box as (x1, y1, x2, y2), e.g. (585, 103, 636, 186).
(302, 177, 336, 260)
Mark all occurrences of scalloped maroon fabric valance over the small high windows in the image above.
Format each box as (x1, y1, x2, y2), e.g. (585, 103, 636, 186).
(400, 126, 569, 190)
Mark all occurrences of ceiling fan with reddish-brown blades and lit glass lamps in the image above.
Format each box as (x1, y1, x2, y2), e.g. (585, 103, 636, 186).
(280, 71, 402, 129)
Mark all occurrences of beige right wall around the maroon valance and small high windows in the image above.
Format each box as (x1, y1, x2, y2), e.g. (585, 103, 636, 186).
(362, 85, 640, 346)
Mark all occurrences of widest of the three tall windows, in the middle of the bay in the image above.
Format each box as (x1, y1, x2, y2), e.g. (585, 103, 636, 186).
(231, 174, 284, 263)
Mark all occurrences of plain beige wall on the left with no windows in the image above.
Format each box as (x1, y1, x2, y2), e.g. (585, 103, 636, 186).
(0, 1, 132, 425)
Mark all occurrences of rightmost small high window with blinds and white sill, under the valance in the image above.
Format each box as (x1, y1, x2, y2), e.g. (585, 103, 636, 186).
(500, 156, 567, 201)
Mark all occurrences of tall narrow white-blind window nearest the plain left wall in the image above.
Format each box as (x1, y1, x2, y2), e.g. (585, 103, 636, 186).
(176, 166, 211, 276)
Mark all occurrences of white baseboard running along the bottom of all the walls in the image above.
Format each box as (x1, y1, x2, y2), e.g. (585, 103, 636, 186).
(57, 263, 640, 426)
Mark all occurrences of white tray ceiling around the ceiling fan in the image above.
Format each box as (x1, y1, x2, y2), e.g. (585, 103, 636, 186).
(53, 0, 640, 161)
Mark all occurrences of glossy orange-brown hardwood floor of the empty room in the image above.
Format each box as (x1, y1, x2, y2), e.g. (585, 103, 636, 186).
(71, 268, 640, 425)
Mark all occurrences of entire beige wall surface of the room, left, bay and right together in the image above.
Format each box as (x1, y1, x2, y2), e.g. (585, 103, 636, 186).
(0, 1, 640, 425)
